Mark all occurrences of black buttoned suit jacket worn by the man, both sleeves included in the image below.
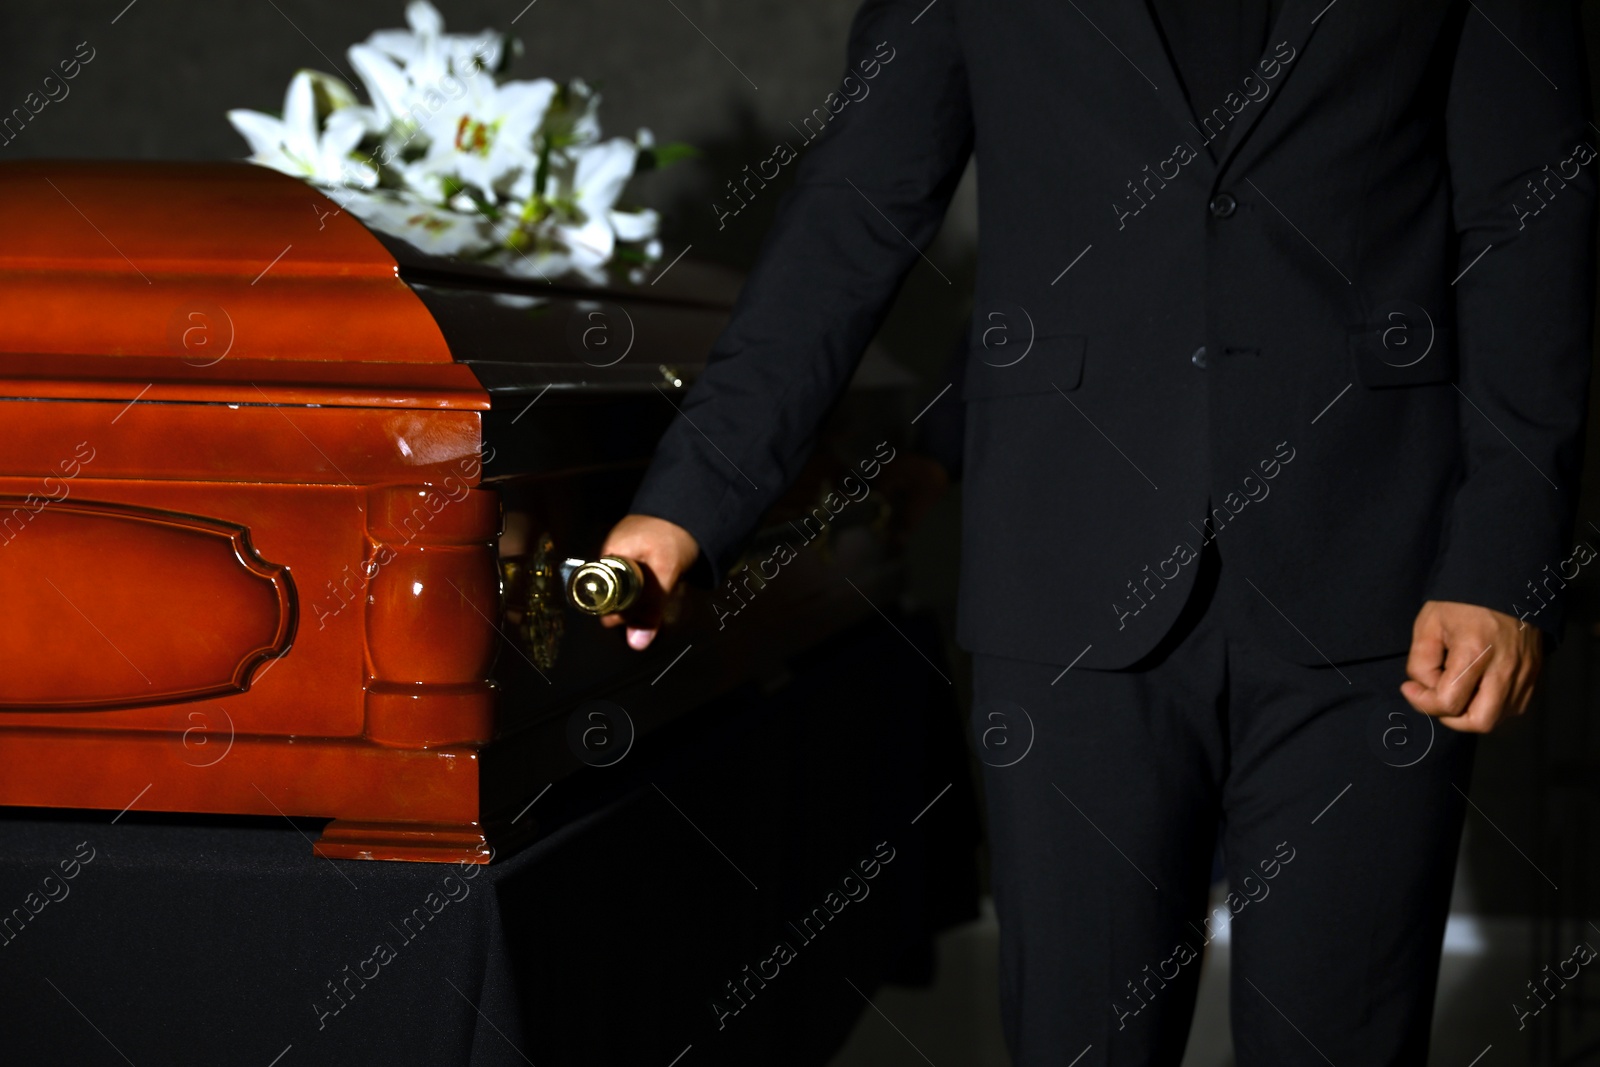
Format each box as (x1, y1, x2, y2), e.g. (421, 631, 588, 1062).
(634, 0, 1600, 667)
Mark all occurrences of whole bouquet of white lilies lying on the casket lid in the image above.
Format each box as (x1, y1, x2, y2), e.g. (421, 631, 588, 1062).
(229, 0, 661, 283)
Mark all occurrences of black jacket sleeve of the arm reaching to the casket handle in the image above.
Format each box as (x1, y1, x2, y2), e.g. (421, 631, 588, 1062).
(632, 0, 973, 584)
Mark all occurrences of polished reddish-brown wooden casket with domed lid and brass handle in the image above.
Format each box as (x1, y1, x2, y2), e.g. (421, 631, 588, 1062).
(0, 162, 912, 862)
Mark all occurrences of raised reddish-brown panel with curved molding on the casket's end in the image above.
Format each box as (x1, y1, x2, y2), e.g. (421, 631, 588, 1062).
(0, 496, 298, 712)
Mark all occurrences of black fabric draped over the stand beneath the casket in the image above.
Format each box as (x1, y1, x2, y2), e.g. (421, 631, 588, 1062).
(0, 617, 976, 1067)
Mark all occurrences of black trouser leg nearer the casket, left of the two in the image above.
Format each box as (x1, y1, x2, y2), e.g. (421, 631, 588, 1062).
(973, 607, 1226, 1067)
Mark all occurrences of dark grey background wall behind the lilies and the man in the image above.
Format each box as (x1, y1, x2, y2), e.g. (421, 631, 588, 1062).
(0, 0, 1600, 1062)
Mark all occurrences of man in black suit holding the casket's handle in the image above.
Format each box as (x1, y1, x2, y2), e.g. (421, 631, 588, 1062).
(606, 0, 1595, 1067)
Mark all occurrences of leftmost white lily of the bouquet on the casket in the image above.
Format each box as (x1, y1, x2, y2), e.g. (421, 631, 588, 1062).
(227, 70, 378, 187)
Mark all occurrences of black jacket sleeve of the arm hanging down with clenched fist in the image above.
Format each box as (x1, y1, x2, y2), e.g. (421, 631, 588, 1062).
(1427, 0, 1600, 637)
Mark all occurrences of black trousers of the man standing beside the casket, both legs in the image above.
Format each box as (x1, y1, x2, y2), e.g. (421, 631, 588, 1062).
(973, 557, 1475, 1067)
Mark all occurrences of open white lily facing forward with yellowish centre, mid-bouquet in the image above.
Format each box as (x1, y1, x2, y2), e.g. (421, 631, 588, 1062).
(422, 75, 555, 200)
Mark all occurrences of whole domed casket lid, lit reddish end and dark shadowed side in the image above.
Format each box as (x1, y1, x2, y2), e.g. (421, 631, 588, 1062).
(0, 162, 741, 410)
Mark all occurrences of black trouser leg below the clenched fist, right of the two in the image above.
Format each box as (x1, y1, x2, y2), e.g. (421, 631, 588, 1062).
(1222, 645, 1474, 1067)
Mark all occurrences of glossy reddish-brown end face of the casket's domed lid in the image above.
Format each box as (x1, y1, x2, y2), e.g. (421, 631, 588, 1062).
(0, 162, 486, 408)
